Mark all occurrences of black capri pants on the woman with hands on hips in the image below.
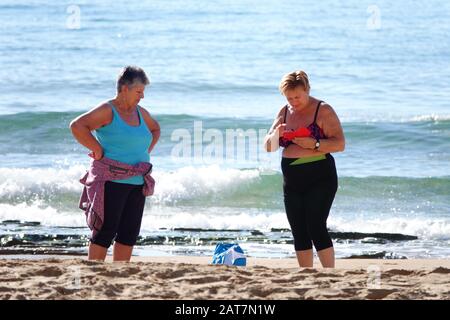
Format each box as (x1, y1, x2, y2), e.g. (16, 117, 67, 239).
(91, 181, 145, 248)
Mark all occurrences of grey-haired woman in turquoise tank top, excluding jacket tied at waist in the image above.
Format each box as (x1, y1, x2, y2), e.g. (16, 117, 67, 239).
(70, 66, 160, 261)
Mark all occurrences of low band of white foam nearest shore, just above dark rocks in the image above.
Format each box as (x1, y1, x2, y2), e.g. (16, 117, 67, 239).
(0, 201, 450, 241)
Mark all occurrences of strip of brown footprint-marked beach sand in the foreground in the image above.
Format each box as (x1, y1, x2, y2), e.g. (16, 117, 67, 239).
(0, 256, 450, 300)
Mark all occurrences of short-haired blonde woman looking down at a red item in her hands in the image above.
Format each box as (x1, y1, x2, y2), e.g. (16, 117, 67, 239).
(265, 71, 345, 267)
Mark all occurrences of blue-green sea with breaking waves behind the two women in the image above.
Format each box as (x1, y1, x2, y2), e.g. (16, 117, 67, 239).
(0, 0, 450, 257)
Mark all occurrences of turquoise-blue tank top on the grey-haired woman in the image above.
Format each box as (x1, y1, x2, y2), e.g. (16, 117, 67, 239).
(95, 102, 151, 185)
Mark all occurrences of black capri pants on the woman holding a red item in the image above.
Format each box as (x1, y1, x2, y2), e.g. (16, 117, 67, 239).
(281, 154, 338, 251)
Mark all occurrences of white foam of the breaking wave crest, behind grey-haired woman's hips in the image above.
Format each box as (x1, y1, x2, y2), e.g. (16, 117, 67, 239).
(0, 165, 260, 203)
